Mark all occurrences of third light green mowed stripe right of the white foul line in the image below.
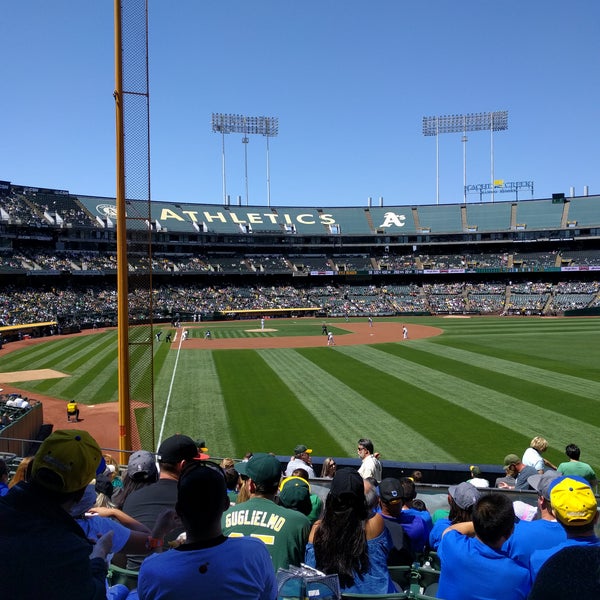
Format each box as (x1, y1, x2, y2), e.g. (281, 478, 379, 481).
(338, 346, 600, 463)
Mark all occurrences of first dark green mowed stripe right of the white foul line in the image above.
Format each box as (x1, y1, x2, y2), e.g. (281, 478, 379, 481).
(213, 350, 336, 456)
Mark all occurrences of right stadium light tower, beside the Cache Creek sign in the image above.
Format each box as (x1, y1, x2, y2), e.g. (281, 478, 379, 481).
(423, 110, 508, 204)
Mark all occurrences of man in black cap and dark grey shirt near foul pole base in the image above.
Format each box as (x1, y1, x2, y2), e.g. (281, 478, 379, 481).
(123, 434, 198, 570)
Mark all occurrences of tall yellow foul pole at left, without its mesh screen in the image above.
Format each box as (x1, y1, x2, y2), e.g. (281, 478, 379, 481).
(114, 0, 131, 464)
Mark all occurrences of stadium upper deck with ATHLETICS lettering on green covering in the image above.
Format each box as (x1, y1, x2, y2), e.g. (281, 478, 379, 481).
(0, 182, 600, 243)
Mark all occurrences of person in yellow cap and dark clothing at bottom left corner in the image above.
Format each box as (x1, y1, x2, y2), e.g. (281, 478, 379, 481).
(0, 429, 113, 600)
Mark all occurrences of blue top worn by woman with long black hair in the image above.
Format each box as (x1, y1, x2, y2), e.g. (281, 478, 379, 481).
(304, 529, 397, 594)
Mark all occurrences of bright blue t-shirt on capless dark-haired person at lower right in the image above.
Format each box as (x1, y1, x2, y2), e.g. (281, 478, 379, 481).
(437, 531, 531, 600)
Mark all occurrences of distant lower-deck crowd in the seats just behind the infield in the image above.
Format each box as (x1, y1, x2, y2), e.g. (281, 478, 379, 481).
(0, 281, 600, 326)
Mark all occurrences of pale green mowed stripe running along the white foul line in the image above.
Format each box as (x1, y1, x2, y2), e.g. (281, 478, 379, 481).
(154, 351, 234, 456)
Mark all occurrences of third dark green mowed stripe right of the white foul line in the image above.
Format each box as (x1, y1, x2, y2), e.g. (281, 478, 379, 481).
(379, 343, 600, 424)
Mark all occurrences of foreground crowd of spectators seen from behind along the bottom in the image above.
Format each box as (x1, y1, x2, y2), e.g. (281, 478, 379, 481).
(0, 430, 600, 600)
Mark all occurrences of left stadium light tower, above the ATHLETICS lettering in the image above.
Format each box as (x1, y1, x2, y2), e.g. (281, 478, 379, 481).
(212, 113, 279, 206)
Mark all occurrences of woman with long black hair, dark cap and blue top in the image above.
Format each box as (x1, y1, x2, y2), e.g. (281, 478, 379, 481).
(305, 469, 396, 594)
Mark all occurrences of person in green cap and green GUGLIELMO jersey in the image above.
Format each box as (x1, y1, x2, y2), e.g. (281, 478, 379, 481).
(222, 453, 310, 571)
